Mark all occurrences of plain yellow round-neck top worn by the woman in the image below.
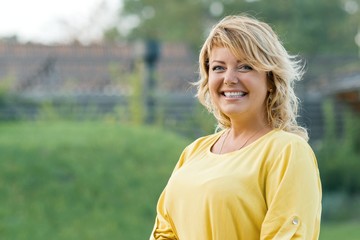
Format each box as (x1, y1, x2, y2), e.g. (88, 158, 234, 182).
(150, 130, 321, 240)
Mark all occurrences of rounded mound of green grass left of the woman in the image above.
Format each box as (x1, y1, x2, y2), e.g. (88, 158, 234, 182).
(0, 122, 188, 240)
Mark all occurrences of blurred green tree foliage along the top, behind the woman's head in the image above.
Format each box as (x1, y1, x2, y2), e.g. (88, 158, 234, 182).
(121, 0, 360, 55)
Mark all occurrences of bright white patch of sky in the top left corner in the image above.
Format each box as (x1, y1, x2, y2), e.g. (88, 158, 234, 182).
(0, 0, 121, 44)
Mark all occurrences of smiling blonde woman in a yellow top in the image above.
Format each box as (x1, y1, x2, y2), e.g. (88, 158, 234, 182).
(150, 16, 321, 240)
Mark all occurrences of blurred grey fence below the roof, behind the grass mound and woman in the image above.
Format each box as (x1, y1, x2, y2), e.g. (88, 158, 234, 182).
(0, 92, 344, 141)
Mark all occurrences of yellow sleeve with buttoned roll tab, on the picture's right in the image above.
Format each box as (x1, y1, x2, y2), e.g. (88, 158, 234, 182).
(260, 141, 321, 240)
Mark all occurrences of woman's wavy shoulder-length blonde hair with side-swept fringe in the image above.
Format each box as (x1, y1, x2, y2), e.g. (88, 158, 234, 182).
(195, 15, 308, 140)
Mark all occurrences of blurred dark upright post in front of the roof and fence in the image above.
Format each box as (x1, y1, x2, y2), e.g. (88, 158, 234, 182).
(144, 39, 160, 124)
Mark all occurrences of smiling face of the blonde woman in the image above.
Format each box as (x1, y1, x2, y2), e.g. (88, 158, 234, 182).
(208, 47, 269, 121)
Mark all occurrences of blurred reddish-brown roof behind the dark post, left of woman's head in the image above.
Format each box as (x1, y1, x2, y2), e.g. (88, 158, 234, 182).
(0, 42, 196, 95)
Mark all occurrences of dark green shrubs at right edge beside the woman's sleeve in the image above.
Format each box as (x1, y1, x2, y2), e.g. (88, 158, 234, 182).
(317, 101, 360, 195)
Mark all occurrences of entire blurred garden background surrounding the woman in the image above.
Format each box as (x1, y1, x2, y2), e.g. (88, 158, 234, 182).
(0, 0, 360, 240)
